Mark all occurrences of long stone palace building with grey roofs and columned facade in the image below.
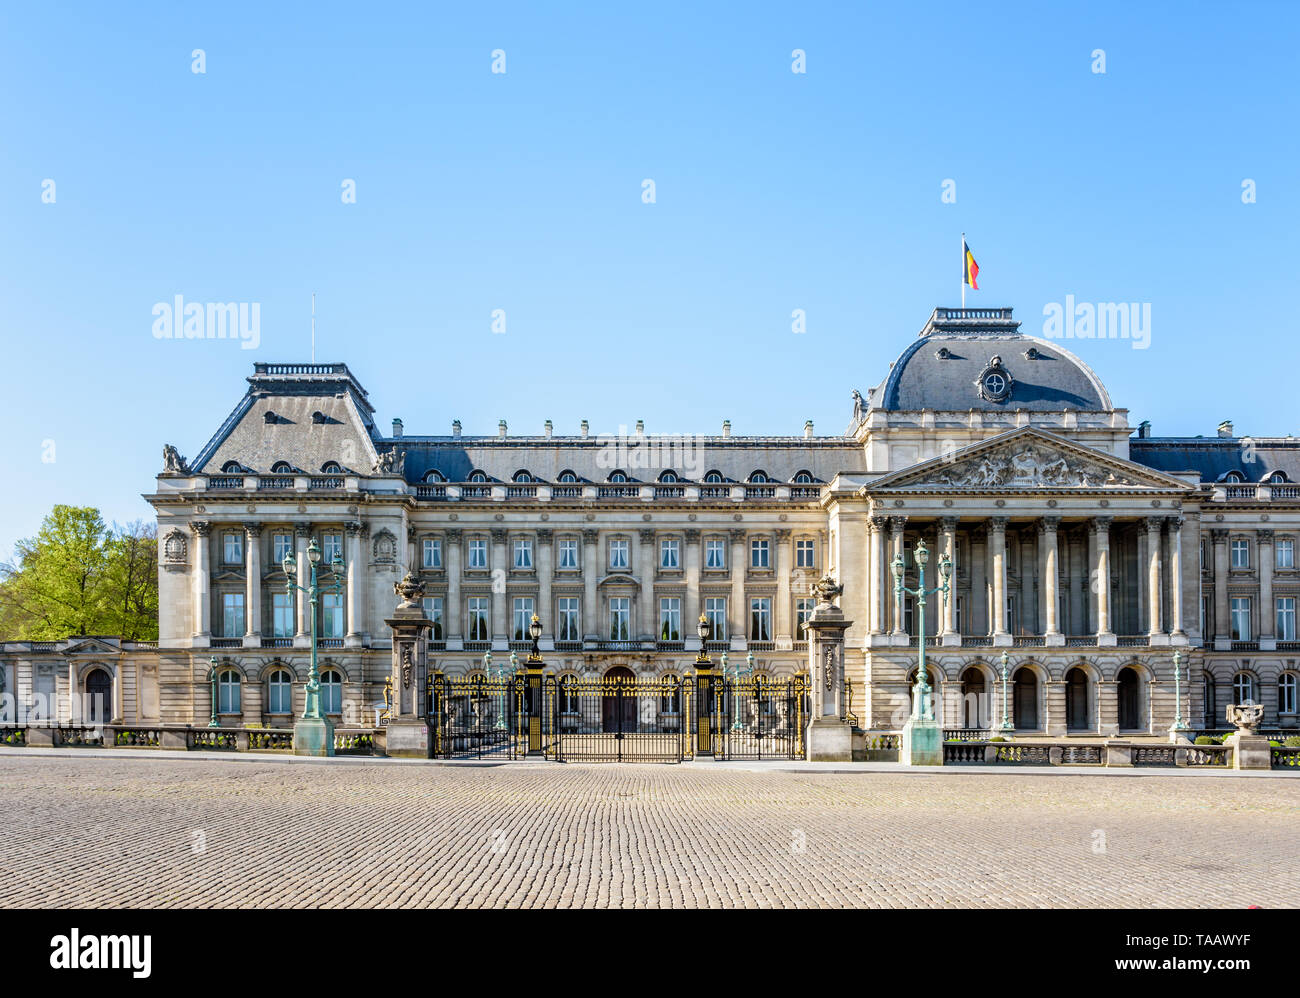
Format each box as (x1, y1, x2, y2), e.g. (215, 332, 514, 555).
(0, 308, 1300, 739)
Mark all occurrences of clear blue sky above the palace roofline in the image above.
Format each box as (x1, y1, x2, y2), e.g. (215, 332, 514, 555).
(0, 3, 1300, 557)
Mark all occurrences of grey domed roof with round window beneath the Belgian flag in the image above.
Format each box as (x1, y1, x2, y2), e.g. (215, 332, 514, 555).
(871, 308, 1112, 412)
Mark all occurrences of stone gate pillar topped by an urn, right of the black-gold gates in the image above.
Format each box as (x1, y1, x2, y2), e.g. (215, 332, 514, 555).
(803, 576, 853, 763)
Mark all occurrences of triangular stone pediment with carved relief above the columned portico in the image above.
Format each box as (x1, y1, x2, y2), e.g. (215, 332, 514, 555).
(865, 426, 1192, 493)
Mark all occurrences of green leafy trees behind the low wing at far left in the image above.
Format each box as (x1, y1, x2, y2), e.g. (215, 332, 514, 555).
(0, 505, 159, 641)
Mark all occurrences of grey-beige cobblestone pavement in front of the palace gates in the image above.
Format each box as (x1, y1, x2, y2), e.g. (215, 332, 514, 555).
(0, 750, 1300, 907)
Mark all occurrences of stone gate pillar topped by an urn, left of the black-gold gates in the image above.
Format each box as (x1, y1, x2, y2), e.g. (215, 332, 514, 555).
(384, 573, 433, 759)
